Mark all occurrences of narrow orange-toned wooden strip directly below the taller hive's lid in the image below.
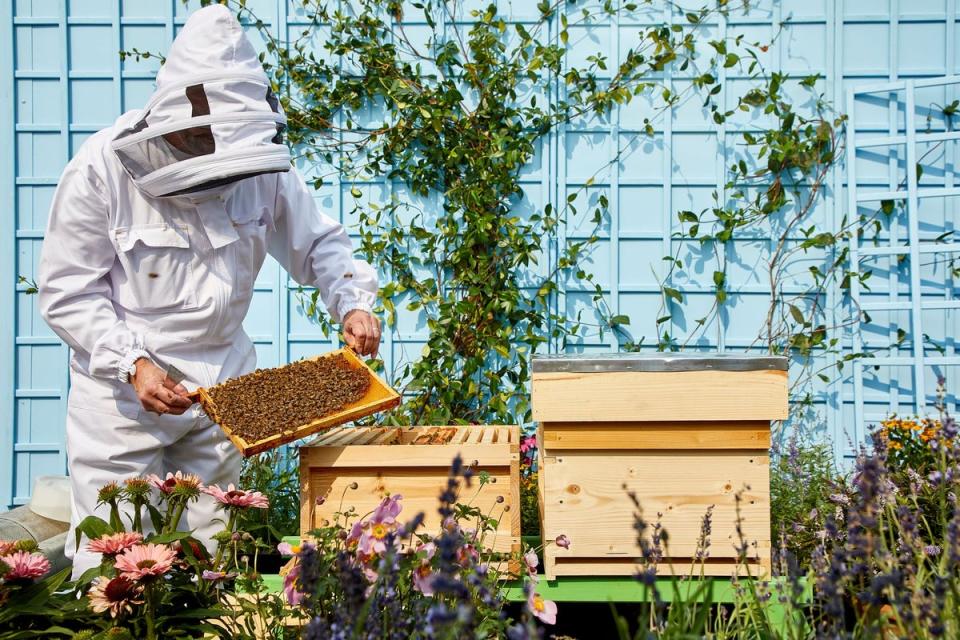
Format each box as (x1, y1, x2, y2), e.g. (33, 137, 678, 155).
(543, 421, 770, 451)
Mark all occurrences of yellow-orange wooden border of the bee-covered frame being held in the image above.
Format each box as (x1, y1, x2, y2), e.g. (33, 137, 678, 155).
(190, 347, 400, 456)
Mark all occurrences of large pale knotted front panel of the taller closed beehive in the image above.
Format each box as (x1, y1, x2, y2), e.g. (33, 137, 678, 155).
(540, 451, 770, 558)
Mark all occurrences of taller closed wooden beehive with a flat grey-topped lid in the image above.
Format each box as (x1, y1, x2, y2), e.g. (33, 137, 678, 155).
(533, 354, 787, 579)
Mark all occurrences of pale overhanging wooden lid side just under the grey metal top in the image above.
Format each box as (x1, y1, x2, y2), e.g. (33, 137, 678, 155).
(532, 370, 787, 422)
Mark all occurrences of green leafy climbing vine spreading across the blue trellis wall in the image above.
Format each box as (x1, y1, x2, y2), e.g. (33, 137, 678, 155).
(212, 0, 869, 423)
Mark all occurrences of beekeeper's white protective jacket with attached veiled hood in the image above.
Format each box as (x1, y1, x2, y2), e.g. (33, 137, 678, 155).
(39, 5, 377, 395)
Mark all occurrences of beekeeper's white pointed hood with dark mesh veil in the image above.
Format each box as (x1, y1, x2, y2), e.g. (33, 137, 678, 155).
(112, 4, 290, 197)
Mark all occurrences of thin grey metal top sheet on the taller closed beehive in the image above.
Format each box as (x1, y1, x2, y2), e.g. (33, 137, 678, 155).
(532, 352, 788, 373)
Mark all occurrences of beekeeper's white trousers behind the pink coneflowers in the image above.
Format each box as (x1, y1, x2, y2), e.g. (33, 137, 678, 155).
(66, 369, 241, 578)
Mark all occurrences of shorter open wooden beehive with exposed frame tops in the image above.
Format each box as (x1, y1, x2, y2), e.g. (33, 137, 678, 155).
(300, 425, 520, 553)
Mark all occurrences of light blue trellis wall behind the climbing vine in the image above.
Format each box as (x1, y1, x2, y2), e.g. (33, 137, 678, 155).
(0, 0, 960, 505)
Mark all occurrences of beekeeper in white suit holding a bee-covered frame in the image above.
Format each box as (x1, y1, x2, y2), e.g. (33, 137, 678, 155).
(39, 5, 380, 575)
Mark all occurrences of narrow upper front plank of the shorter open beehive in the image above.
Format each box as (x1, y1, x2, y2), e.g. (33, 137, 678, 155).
(309, 444, 510, 469)
